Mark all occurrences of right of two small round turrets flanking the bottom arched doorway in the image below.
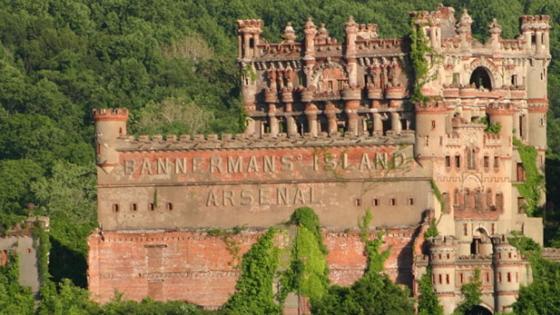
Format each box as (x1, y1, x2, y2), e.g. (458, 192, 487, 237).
(492, 235, 525, 311)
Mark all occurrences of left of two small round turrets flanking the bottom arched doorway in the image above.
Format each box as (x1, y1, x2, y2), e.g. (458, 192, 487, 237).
(430, 236, 457, 314)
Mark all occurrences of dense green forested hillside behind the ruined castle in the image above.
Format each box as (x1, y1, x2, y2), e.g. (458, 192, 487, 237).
(0, 0, 560, 308)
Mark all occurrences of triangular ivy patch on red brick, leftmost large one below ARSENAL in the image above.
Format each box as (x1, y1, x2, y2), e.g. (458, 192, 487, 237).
(222, 228, 280, 314)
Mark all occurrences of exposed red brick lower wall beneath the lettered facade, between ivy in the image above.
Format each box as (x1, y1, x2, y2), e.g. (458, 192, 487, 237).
(88, 227, 416, 309)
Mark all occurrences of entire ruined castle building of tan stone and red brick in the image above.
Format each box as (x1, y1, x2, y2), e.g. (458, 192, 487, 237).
(88, 7, 548, 314)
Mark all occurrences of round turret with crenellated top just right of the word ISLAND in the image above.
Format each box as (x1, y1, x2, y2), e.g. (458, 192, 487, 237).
(414, 101, 447, 160)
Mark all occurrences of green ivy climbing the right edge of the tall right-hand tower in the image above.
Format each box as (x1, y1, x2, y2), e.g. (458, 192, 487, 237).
(513, 138, 544, 216)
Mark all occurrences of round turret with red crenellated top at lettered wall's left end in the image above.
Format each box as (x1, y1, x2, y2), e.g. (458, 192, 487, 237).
(93, 108, 128, 170)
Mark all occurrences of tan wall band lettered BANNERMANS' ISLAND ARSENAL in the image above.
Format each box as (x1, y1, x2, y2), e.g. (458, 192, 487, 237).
(98, 144, 433, 230)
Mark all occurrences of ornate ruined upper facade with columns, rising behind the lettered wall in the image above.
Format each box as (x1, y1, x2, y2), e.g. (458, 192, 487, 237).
(238, 17, 413, 137)
